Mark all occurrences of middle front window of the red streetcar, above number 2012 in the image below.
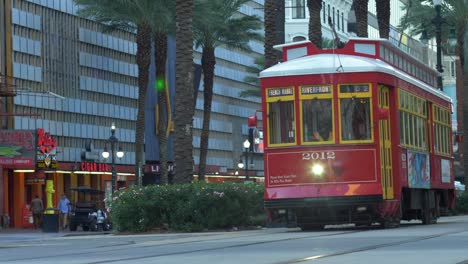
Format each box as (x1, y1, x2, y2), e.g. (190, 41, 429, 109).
(302, 99, 333, 142)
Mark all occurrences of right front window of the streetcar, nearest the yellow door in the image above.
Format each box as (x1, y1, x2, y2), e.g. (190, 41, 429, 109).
(340, 97, 372, 140)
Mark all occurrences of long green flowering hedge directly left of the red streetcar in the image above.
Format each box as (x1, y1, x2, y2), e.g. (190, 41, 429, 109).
(111, 183, 265, 232)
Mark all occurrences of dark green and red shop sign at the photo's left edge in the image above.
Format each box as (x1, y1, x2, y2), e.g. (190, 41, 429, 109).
(0, 130, 36, 169)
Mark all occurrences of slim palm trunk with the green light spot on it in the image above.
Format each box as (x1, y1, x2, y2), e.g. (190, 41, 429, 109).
(154, 32, 168, 184)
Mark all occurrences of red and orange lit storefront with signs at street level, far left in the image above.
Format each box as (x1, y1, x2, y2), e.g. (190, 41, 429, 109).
(0, 129, 135, 228)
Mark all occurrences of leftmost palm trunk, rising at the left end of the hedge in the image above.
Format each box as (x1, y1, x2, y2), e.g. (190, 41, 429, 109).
(135, 23, 151, 182)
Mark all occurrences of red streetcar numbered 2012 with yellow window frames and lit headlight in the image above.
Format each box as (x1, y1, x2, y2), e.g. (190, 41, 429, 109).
(260, 38, 455, 230)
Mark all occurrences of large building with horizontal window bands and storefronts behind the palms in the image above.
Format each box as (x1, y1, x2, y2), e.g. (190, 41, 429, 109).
(0, 0, 263, 227)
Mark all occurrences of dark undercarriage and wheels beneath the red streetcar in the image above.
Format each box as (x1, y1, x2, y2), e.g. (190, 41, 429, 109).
(265, 188, 453, 230)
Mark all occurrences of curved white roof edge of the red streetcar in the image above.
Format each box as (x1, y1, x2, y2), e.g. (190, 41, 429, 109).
(260, 54, 452, 101)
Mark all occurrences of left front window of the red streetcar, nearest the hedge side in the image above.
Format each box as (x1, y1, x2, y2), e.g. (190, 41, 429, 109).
(268, 101, 295, 144)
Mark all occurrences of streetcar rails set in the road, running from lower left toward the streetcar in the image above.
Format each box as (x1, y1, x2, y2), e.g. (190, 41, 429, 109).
(3, 229, 362, 264)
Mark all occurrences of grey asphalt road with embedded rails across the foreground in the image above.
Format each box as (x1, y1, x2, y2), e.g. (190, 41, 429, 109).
(0, 216, 468, 264)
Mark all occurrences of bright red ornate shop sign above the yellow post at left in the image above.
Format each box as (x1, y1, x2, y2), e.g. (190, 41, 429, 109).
(37, 128, 58, 169)
